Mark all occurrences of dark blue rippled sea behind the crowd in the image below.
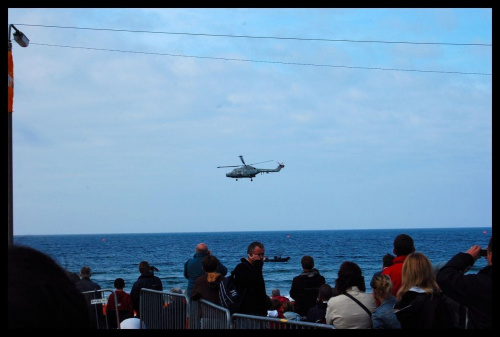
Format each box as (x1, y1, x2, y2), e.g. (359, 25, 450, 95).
(14, 227, 492, 296)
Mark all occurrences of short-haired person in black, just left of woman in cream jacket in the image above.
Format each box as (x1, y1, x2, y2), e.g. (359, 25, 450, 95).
(290, 255, 326, 316)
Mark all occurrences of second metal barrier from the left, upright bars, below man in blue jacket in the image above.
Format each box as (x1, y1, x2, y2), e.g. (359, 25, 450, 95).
(139, 288, 190, 329)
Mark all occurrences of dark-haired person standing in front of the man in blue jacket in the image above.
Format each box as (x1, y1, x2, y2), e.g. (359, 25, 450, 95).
(190, 255, 224, 305)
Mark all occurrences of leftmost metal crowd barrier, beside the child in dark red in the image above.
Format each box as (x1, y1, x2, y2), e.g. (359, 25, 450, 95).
(82, 289, 120, 329)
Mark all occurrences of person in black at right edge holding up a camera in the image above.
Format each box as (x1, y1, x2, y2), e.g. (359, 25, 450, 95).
(436, 238, 493, 329)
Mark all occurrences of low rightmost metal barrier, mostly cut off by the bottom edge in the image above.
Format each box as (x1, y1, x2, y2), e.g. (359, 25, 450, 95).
(231, 314, 335, 329)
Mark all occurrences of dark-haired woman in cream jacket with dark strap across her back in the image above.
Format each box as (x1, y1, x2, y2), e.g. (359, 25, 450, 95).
(326, 261, 377, 329)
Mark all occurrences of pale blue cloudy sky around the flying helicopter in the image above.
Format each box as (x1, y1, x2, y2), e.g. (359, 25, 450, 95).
(8, 8, 492, 235)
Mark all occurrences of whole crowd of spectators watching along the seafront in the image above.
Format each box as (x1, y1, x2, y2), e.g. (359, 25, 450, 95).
(8, 234, 493, 329)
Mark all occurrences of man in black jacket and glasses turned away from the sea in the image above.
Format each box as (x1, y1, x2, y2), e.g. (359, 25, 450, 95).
(233, 241, 272, 316)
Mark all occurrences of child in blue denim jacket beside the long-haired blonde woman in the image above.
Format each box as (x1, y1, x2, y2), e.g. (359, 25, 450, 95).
(370, 274, 401, 329)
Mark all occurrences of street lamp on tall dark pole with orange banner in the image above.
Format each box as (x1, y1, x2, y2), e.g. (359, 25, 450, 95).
(7, 24, 30, 246)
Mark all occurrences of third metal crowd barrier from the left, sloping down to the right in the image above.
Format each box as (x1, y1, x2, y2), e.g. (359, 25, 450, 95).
(189, 299, 231, 329)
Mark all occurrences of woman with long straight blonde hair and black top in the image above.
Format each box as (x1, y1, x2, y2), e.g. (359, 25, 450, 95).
(394, 252, 452, 329)
